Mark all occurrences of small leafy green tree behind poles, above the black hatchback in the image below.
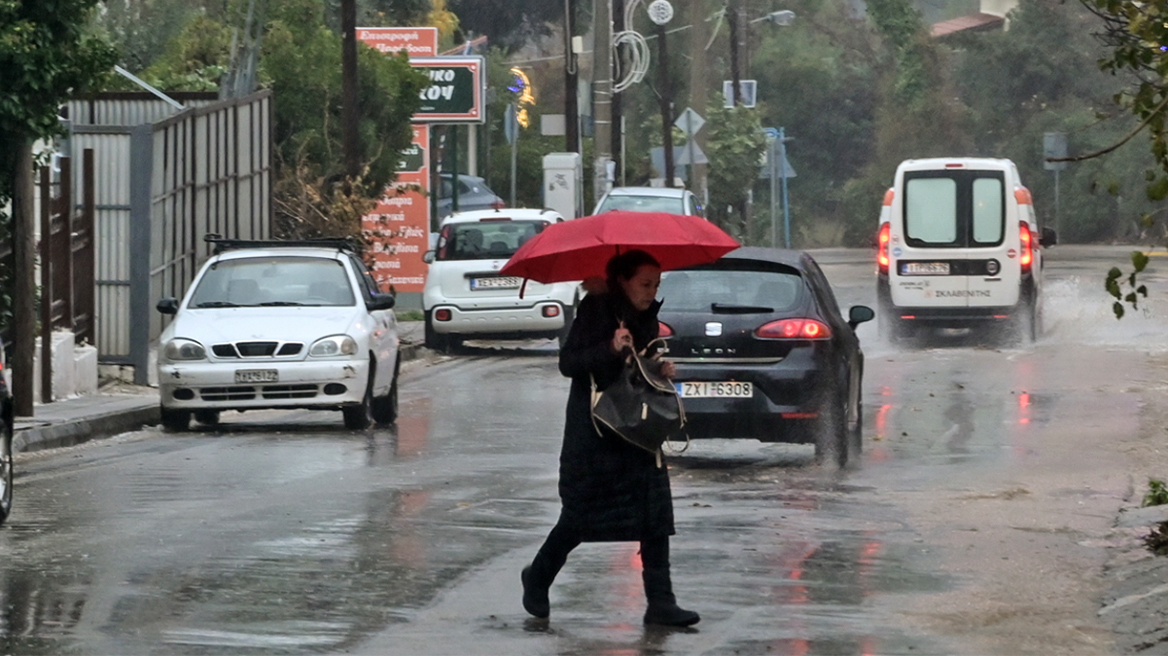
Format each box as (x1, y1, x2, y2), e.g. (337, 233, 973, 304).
(705, 102, 766, 242)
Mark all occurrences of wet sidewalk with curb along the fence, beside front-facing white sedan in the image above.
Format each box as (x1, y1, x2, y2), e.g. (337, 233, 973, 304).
(13, 321, 423, 453)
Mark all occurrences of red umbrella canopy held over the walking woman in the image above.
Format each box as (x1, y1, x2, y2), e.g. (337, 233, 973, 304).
(499, 210, 738, 282)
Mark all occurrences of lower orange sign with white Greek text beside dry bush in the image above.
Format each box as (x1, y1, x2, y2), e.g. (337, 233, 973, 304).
(362, 125, 430, 292)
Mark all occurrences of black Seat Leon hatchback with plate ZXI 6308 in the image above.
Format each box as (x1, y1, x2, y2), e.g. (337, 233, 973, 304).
(659, 247, 875, 467)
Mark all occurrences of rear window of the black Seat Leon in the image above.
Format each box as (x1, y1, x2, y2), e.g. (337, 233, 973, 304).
(658, 268, 804, 313)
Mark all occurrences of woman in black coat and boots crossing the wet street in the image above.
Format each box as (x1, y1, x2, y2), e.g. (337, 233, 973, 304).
(522, 251, 701, 627)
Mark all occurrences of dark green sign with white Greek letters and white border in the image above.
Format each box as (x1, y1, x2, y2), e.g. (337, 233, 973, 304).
(410, 56, 486, 123)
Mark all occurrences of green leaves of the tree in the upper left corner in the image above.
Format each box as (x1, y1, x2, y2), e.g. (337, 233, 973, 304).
(0, 0, 116, 328)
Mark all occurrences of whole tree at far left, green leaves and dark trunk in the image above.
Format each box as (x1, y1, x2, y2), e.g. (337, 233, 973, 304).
(0, 0, 116, 416)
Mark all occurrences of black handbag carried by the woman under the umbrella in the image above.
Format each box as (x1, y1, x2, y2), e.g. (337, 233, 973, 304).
(592, 338, 686, 466)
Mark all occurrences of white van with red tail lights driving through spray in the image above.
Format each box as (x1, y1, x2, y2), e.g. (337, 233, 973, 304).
(876, 158, 1056, 342)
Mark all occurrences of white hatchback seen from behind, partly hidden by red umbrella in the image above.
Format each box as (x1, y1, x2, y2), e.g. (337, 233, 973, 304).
(422, 208, 580, 351)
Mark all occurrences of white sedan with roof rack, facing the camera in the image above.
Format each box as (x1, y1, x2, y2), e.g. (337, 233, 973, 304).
(158, 236, 401, 431)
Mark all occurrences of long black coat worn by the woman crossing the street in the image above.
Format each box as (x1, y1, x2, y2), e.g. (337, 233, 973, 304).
(559, 293, 674, 542)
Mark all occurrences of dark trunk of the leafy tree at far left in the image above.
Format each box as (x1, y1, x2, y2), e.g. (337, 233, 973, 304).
(12, 140, 35, 417)
